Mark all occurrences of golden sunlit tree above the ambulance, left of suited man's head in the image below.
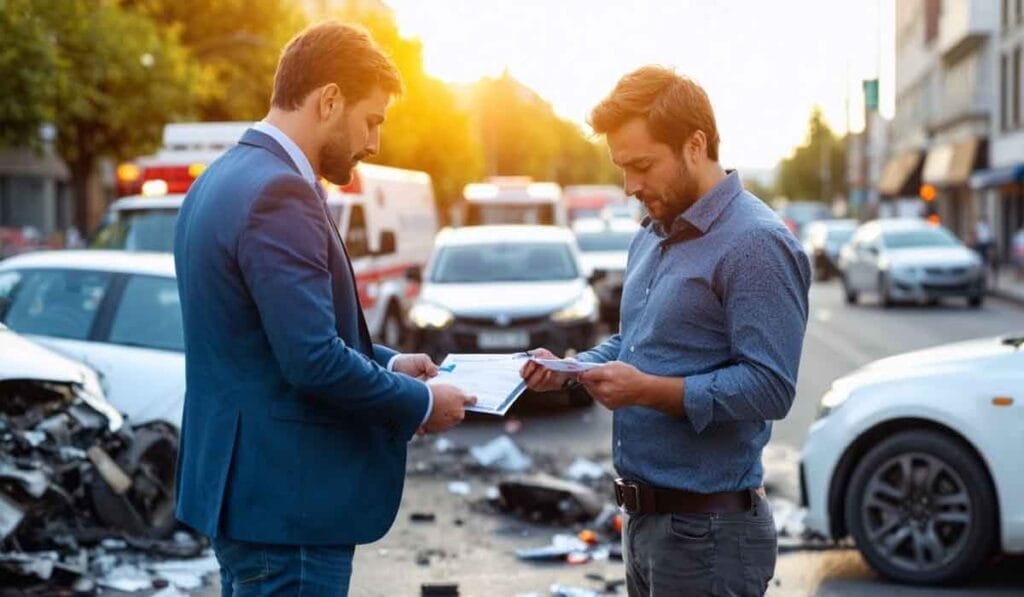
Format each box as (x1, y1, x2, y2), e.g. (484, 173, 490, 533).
(123, 0, 305, 121)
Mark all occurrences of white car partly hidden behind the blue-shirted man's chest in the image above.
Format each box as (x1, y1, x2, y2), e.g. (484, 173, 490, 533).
(572, 218, 640, 329)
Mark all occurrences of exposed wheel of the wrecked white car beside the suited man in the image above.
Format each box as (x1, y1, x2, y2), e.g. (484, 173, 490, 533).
(90, 423, 178, 539)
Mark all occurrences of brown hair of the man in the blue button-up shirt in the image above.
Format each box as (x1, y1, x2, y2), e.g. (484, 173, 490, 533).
(590, 66, 719, 162)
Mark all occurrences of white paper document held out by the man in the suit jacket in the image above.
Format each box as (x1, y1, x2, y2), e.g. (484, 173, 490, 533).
(427, 352, 527, 416)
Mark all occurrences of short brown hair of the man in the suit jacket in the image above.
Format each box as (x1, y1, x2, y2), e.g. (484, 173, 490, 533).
(270, 22, 401, 110)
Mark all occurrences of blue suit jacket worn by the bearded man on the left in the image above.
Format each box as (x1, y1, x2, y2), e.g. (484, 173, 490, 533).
(174, 129, 429, 545)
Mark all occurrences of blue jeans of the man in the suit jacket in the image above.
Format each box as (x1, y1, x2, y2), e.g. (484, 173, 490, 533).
(212, 537, 355, 597)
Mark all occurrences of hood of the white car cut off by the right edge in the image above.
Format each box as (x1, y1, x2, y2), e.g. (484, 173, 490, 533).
(834, 337, 1024, 387)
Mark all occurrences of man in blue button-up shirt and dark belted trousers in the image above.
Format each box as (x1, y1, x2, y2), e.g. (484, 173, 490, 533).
(522, 67, 810, 595)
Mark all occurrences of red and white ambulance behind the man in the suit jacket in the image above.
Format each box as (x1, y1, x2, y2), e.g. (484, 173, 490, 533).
(99, 123, 438, 347)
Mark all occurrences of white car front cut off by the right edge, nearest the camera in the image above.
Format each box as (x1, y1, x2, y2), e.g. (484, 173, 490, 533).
(800, 336, 1024, 584)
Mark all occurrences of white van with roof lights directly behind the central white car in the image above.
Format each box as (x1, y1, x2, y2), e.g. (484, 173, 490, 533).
(463, 176, 567, 226)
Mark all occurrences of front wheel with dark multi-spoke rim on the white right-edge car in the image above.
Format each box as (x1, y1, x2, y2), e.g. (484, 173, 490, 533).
(845, 429, 996, 584)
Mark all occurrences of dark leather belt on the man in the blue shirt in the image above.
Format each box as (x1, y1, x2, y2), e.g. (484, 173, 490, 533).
(615, 478, 764, 514)
